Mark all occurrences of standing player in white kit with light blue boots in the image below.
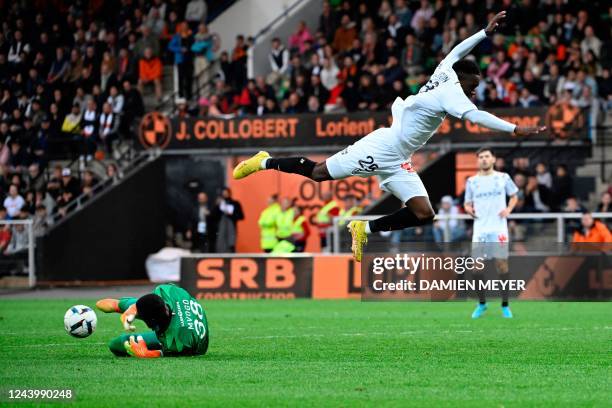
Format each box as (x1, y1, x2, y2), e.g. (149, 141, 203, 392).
(464, 147, 518, 319)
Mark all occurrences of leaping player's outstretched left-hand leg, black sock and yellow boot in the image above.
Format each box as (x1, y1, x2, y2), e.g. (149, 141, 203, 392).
(233, 151, 332, 181)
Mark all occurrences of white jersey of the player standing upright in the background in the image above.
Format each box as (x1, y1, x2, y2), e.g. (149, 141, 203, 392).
(465, 171, 518, 242)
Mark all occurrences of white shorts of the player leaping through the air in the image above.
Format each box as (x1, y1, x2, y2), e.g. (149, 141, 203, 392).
(325, 128, 428, 203)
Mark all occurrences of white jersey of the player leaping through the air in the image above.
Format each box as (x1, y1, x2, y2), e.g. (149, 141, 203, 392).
(391, 30, 486, 154)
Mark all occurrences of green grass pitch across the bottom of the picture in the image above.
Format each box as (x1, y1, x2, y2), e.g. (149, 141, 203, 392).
(0, 299, 612, 407)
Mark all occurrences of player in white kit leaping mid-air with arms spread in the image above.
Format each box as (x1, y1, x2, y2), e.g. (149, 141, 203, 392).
(233, 11, 545, 261)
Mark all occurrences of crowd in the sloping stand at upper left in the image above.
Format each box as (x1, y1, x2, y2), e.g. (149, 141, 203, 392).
(0, 0, 213, 254)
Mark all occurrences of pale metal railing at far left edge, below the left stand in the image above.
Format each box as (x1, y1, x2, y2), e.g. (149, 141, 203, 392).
(0, 219, 36, 288)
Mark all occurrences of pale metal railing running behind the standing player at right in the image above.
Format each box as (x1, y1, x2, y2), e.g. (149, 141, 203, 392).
(327, 212, 612, 253)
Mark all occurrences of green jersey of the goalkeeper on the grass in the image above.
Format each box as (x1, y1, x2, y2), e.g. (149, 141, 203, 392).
(153, 284, 208, 354)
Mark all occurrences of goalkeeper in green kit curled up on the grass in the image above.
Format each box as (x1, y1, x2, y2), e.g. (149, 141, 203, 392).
(96, 284, 208, 358)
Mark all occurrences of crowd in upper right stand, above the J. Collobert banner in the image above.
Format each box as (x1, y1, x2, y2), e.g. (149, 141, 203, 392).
(189, 0, 612, 116)
